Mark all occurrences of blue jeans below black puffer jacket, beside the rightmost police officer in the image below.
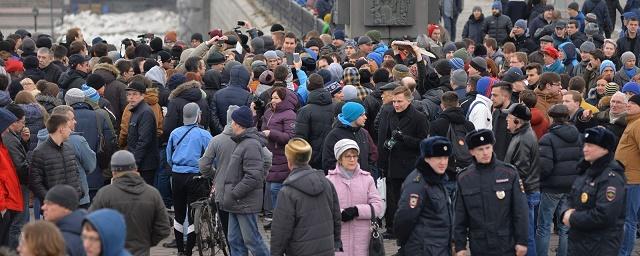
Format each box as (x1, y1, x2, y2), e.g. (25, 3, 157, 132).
(536, 193, 569, 256)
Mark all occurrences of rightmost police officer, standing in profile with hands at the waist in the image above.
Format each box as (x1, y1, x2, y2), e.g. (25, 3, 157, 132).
(562, 127, 625, 255)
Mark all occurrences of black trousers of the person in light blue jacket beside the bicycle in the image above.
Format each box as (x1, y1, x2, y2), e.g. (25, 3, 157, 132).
(171, 172, 201, 255)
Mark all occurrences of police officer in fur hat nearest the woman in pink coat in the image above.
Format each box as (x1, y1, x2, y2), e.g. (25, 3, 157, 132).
(393, 136, 453, 255)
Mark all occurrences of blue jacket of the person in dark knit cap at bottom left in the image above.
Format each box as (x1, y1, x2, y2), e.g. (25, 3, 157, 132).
(56, 209, 87, 256)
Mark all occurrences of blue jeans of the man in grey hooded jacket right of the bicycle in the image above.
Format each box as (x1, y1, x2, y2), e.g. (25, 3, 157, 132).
(228, 213, 270, 256)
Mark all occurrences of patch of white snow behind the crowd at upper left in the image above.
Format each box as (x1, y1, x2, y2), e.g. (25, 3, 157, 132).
(55, 9, 178, 46)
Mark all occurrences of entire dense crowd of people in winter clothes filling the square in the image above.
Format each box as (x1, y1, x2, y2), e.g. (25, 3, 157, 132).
(0, 0, 640, 256)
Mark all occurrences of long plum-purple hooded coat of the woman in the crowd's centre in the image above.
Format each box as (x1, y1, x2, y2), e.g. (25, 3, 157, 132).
(262, 90, 298, 183)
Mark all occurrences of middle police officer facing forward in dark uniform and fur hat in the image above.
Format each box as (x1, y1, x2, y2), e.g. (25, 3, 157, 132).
(453, 129, 535, 256)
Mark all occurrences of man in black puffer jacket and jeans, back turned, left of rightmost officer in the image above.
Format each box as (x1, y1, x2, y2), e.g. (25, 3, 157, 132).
(536, 104, 582, 255)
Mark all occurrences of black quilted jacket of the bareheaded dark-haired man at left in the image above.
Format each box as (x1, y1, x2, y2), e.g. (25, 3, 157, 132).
(29, 137, 83, 202)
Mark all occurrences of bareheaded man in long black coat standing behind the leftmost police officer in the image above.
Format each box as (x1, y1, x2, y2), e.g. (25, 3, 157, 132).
(378, 86, 429, 239)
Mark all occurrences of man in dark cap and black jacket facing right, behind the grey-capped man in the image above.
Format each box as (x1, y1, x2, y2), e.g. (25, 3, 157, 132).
(127, 82, 160, 185)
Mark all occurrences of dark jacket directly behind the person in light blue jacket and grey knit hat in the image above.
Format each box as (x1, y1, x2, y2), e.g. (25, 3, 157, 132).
(162, 81, 209, 141)
